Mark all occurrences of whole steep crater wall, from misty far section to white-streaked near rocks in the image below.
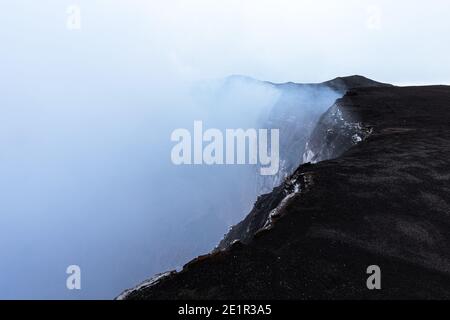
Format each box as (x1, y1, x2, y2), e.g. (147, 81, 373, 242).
(223, 76, 392, 250)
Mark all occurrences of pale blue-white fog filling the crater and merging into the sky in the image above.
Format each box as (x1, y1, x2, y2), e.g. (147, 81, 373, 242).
(0, 0, 450, 299)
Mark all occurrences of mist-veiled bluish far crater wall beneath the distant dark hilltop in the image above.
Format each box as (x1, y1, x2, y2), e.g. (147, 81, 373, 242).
(256, 76, 391, 195)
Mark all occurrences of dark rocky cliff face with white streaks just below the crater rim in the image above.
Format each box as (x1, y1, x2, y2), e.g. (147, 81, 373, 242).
(217, 99, 373, 250)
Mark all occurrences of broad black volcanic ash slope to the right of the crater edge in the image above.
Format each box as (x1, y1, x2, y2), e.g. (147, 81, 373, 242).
(123, 86, 450, 299)
